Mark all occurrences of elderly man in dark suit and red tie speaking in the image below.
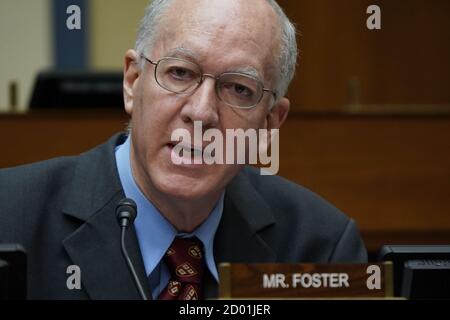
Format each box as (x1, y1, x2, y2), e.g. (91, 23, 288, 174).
(0, 0, 367, 299)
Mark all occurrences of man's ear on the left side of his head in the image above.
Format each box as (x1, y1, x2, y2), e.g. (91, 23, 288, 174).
(123, 49, 139, 115)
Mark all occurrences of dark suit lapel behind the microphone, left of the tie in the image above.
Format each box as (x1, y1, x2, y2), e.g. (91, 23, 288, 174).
(63, 136, 151, 299)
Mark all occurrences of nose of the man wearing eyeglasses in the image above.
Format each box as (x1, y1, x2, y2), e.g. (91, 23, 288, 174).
(181, 75, 219, 127)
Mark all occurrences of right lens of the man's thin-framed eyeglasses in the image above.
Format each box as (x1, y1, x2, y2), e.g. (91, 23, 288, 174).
(217, 73, 263, 108)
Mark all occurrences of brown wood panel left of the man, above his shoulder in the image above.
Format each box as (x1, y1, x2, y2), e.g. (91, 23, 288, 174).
(0, 110, 128, 168)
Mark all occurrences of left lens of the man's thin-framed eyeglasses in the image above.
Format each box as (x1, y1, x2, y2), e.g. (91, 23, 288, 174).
(156, 58, 201, 93)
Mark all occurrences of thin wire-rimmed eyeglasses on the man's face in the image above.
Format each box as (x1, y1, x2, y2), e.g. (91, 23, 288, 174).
(141, 55, 276, 109)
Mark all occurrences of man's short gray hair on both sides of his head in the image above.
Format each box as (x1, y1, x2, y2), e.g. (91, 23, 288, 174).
(135, 0, 298, 98)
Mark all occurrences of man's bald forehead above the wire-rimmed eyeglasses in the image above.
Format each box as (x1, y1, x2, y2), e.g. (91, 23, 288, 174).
(155, 0, 279, 80)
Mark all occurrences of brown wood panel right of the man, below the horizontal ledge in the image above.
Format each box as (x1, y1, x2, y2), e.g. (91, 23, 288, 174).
(280, 115, 450, 251)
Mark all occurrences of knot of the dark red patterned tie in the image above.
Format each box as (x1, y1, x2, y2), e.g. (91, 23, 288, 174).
(164, 237, 204, 283)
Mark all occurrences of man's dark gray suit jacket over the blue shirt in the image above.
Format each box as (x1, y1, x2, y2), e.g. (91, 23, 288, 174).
(0, 135, 367, 299)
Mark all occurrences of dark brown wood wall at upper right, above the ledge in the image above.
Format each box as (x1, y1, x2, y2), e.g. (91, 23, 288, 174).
(278, 0, 450, 111)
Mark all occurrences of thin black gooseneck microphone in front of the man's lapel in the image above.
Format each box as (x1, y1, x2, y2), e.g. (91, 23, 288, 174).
(116, 198, 148, 300)
